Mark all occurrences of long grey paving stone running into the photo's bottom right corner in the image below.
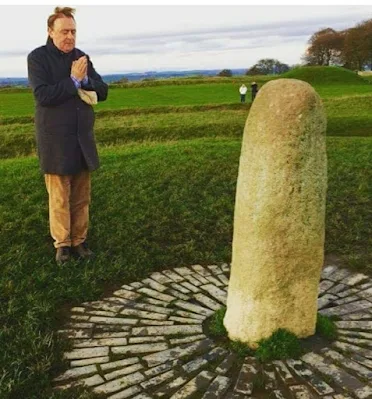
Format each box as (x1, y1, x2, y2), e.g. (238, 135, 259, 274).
(302, 352, 372, 398)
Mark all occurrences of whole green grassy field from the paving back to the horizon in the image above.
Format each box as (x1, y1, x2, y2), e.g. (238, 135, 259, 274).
(0, 67, 372, 399)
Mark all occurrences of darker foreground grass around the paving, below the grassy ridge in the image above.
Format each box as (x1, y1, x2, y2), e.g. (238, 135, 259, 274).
(0, 138, 372, 399)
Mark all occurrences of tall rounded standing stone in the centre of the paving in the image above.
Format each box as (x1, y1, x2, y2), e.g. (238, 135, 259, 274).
(224, 79, 327, 348)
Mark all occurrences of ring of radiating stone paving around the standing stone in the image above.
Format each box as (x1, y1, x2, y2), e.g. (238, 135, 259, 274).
(55, 264, 372, 399)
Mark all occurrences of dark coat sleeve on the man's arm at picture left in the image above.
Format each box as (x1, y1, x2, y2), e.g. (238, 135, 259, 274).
(27, 53, 77, 106)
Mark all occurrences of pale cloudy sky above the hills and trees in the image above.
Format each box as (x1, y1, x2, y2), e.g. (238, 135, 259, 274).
(0, 3, 372, 77)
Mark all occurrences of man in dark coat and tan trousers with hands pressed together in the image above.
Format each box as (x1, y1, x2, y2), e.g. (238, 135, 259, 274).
(27, 7, 108, 264)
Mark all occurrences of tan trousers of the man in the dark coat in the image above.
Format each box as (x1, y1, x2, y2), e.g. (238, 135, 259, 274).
(45, 171, 90, 248)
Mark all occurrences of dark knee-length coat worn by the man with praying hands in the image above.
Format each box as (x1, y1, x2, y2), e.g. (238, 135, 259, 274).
(27, 38, 108, 175)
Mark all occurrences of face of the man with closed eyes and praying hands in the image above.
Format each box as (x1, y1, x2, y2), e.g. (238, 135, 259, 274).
(48, 17, 76, 53)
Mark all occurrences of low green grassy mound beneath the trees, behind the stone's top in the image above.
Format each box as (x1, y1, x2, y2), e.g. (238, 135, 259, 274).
(282, 66, 368, 85)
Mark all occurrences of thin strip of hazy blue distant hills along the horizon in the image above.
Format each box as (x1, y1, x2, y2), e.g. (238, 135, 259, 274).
(0, 69, 250, 87)
